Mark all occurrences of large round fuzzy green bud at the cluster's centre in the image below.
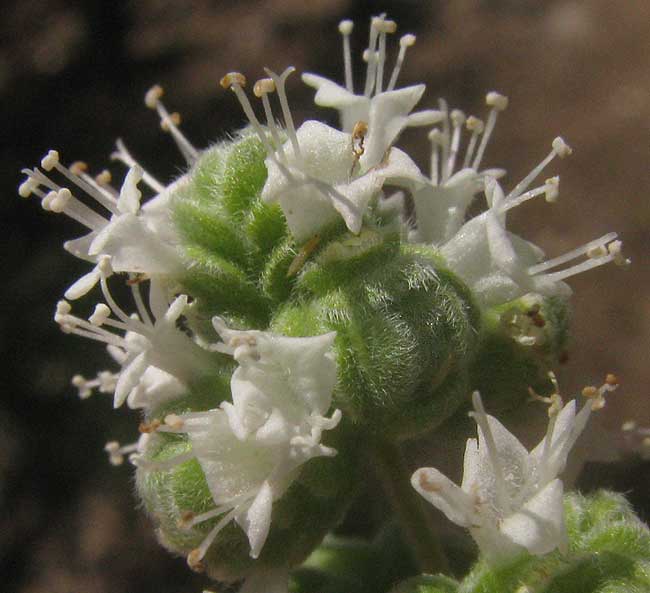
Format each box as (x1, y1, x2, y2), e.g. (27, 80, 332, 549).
(271, 237, 479, 438)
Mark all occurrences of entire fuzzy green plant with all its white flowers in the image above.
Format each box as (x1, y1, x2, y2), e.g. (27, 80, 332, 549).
(19, 15, 650, 593)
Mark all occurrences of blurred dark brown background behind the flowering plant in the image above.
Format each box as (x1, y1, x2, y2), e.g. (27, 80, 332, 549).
(0, 0, 650, 593)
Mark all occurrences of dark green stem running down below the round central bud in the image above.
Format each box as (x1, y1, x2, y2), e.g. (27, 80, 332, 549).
(373, 440, 450, 574)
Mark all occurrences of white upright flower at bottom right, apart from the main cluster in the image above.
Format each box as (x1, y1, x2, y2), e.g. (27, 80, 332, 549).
(411, 375, 617, 562)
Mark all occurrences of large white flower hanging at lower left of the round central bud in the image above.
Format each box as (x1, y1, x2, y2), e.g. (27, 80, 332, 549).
(136, 318, 341, 568)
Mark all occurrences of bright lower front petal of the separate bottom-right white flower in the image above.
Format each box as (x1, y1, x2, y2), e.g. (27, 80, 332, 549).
(499, 479, 567, 555)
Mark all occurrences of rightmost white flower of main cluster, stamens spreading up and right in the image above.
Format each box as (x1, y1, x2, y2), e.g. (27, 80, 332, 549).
(440, 138, 629, 307)
